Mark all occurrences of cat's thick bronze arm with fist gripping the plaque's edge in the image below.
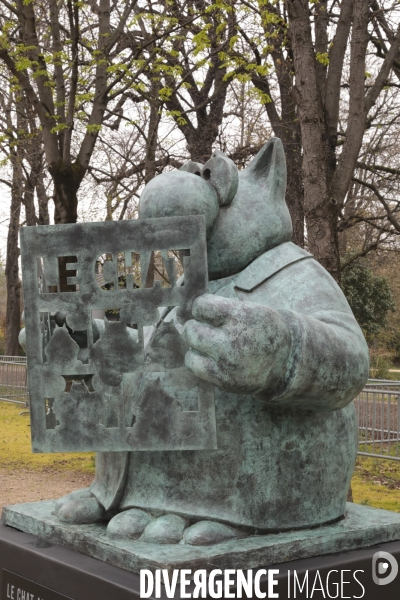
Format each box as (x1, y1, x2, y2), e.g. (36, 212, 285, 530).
(185, 261, 369, 410)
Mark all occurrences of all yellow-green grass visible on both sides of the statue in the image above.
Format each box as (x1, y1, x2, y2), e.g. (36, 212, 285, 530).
(0, 402, 400, 512)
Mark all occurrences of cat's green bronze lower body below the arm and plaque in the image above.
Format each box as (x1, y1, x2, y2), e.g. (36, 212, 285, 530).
(120, 388, 357, 530)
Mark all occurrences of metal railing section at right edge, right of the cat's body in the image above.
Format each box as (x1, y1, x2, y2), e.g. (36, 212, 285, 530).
(354, 379, 400, 460)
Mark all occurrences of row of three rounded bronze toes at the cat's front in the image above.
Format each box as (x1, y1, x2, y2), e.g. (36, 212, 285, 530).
(107, 508, 248, 546)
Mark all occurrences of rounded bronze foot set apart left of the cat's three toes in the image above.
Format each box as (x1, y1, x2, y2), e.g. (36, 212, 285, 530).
(54, 488, 107, 525)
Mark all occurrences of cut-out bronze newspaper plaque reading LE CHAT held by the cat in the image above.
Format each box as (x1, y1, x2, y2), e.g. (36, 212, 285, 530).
(21, 216, 216, 452)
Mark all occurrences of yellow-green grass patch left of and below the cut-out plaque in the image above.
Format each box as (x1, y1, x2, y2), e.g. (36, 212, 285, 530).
(0, 402, 94, 473)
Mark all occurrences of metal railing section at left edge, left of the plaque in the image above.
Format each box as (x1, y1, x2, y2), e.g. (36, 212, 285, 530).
(0, 356, 29, 407)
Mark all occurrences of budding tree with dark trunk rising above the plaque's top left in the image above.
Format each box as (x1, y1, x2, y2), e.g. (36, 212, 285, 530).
(0, 0, 186, 223)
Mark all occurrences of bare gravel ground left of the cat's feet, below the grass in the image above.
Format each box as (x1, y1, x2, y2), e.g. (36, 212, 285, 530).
(0, 469, 94, 512)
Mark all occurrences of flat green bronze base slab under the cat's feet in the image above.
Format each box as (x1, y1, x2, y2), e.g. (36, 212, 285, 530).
(2, 501, 400, 573)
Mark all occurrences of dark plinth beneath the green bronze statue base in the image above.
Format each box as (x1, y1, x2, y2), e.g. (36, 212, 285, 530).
(0, 524, 400, 600)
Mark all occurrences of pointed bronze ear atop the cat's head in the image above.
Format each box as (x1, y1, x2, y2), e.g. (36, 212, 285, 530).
(243, 138, 286, 200)
